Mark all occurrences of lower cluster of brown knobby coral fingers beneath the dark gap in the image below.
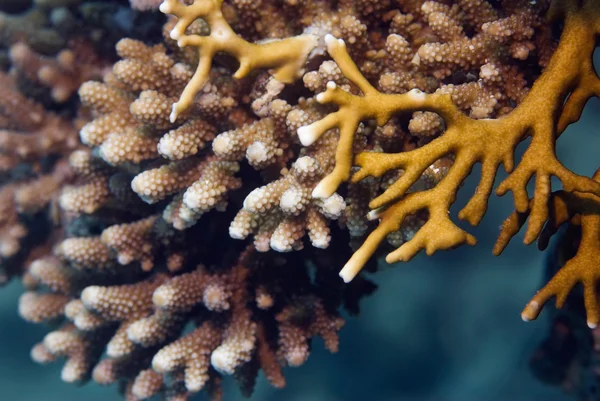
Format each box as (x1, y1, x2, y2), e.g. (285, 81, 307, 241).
(19, 225, 373, 399)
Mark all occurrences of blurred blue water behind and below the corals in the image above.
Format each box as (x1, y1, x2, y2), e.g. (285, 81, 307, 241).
(0, 54, 600, 401)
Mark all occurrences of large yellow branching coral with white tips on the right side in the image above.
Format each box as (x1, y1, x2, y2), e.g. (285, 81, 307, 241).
(298, 0, 600, 312)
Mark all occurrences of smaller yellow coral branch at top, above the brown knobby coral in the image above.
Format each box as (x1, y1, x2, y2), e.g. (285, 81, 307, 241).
(160, 0, 317, 122)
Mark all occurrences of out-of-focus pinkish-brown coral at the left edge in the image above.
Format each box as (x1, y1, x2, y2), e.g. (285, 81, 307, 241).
(0, 73, 78, 283)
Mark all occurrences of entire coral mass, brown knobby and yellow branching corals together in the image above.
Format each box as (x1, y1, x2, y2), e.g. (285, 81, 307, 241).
(0, 0, 600, 401)
